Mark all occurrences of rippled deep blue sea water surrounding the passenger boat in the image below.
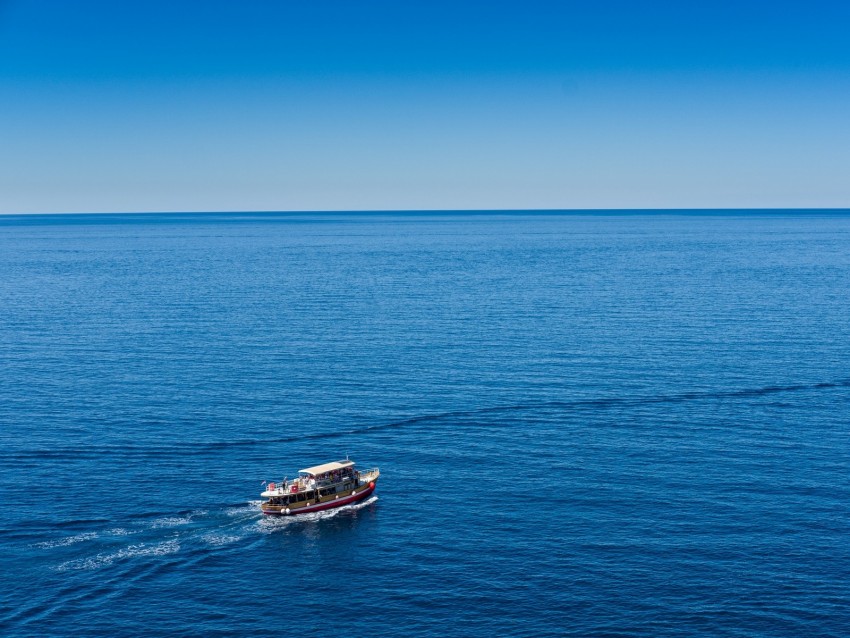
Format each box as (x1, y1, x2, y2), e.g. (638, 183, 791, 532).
(0, 211, 850, 637)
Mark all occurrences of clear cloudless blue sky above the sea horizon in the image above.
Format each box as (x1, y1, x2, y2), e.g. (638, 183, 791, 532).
(0, 0, 850, 213)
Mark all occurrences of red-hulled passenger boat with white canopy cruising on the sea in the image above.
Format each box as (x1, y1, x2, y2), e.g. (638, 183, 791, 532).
(260, 459, 381, 516)
